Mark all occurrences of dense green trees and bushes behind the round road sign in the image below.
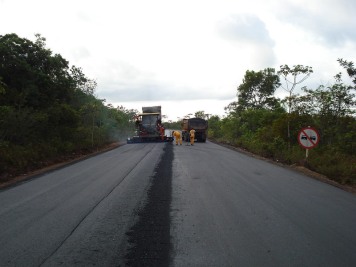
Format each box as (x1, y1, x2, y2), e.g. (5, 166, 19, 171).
(209, 62, 356, 185)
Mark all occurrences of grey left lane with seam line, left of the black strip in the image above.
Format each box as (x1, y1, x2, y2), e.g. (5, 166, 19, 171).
(0, 144, 163, 267)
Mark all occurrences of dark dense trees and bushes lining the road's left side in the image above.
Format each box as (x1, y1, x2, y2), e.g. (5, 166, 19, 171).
(0, 34, 134, 181)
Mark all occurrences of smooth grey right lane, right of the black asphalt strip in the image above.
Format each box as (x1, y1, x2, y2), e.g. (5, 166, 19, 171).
(171, 143, 356, 266)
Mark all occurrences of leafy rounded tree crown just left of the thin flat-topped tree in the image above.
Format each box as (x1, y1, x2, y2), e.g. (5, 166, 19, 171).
(237, 68, 280, 111)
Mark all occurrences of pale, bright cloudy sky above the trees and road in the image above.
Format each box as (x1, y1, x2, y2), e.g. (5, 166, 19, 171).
(0, 0, 356, 121)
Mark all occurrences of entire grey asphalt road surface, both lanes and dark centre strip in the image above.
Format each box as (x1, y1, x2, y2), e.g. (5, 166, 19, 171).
(0, 142, 356, 266)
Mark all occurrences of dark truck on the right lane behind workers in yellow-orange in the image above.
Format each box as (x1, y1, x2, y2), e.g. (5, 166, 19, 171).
(182, 118, 208, 142)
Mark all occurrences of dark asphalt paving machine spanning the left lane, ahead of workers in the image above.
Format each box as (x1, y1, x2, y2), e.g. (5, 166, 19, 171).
(127, 106, 173, 144)
